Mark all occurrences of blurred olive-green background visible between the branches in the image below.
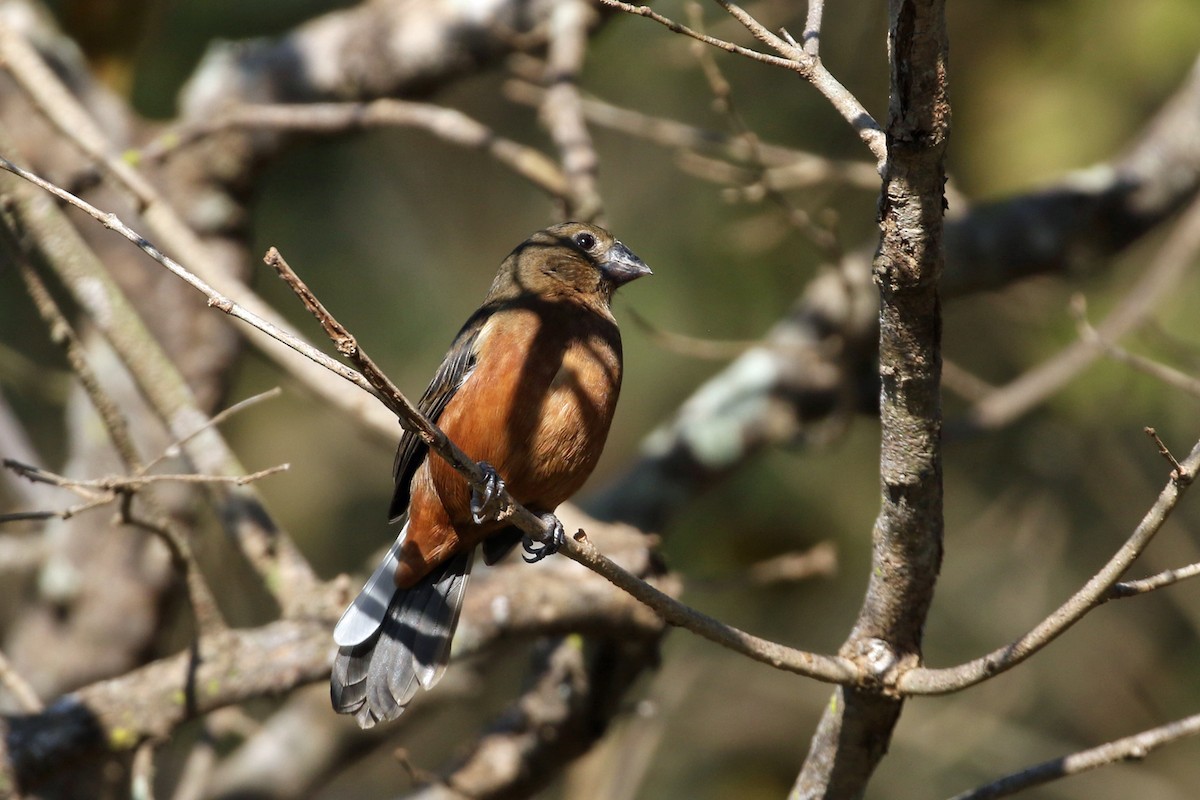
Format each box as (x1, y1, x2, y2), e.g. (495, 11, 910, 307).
(7, 0, 1200, 800)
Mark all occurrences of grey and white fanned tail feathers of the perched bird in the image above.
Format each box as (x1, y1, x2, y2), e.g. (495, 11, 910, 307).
(330, 548, 474, 728)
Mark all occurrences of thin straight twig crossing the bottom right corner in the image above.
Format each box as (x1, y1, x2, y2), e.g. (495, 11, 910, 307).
(952, 714, 1200, 800)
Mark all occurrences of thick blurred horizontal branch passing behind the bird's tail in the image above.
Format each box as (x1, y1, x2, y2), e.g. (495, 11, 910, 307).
(0, 525, 676, 799)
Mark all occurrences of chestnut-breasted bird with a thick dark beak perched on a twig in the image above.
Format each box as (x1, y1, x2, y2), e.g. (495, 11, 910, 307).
(330, 222, 652, 728)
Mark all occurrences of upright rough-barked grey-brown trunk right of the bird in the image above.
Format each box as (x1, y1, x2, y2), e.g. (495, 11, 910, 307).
(792, 0, 949, 798)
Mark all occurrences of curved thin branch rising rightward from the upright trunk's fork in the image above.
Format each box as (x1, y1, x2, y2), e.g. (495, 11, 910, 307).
(896, 431, 1200, 694)
